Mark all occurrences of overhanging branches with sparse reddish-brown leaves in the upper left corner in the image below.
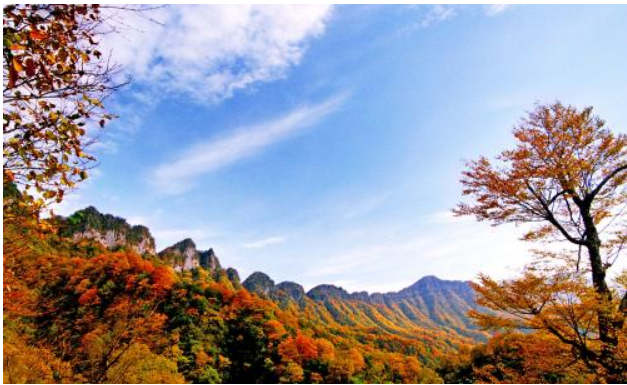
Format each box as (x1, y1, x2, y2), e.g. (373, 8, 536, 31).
(3, 4, 124, 216)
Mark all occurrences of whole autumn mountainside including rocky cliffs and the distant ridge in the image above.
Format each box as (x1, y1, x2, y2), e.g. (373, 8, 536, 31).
(5, 201, 464, 383)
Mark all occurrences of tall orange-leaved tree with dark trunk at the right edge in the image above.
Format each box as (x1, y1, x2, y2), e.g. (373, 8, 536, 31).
(454, 102, 627, 381)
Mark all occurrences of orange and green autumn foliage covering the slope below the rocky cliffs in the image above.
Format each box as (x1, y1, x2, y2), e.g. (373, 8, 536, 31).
(4, 220, 456, 383)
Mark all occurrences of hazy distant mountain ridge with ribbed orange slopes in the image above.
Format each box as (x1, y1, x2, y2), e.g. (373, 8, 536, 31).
(243, 272, 486, 340)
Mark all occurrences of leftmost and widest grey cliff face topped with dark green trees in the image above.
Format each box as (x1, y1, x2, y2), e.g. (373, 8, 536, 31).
(60, 206, 155, 254)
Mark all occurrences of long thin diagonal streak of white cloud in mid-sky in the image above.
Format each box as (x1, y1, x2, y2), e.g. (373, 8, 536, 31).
(151, 94, 346, 194)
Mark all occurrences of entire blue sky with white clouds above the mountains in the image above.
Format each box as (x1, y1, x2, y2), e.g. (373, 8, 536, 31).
(57, 6, 627, 291)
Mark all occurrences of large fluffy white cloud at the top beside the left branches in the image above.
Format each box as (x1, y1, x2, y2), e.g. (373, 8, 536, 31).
(103, 5, 331, 103)
